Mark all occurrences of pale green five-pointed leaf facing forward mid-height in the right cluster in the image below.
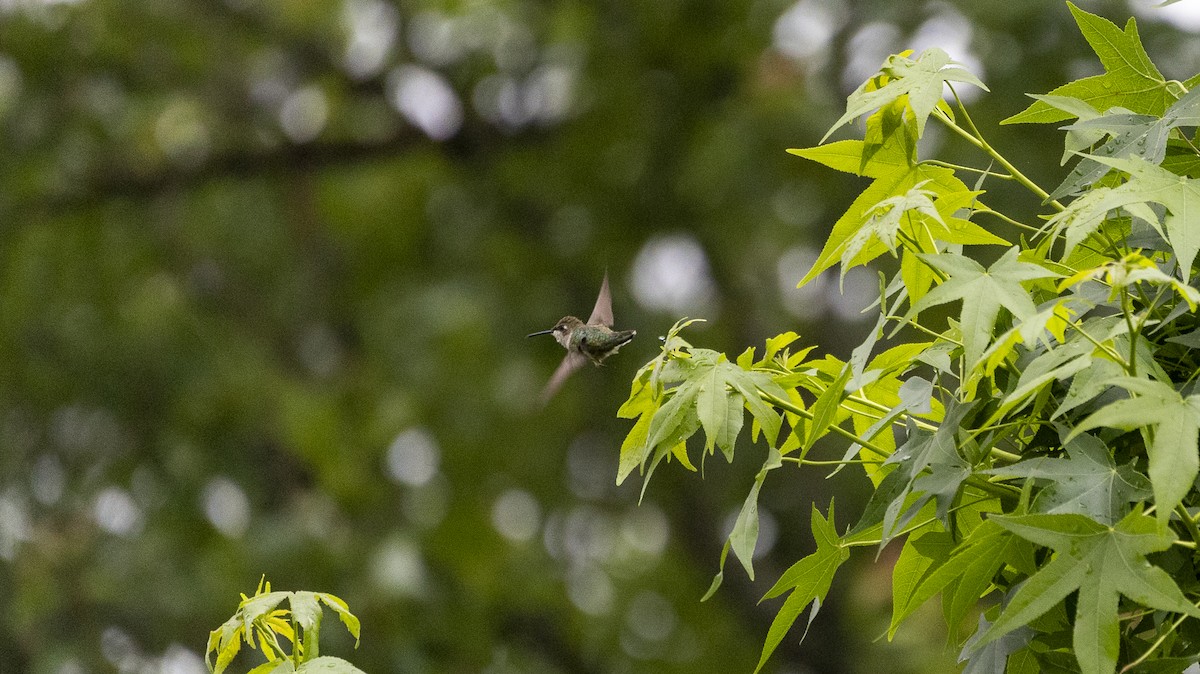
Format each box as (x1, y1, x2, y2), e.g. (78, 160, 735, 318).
(905, 247, 1057, 368)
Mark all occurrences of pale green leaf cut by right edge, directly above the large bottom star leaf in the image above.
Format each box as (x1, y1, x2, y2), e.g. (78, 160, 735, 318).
(1067, 377, 1200, 522)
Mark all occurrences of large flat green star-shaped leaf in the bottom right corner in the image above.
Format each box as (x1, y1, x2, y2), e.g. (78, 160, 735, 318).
(976, 508, 1200, 674)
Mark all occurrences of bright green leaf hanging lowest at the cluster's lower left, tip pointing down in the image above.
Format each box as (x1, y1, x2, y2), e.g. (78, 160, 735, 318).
(755, 501, 850, 673)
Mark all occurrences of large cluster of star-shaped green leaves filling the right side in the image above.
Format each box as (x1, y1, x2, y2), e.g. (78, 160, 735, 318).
(618, 5, 1200, 673)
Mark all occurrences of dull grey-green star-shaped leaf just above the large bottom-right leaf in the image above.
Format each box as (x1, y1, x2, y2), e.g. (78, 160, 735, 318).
(983, 426, 1151, 524)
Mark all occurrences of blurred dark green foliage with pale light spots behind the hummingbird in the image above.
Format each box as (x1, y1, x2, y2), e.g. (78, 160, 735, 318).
(0, 0, 1200, 674)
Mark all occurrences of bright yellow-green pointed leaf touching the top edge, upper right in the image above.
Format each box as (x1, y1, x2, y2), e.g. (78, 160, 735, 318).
(1001, 2, 1177, 124)
